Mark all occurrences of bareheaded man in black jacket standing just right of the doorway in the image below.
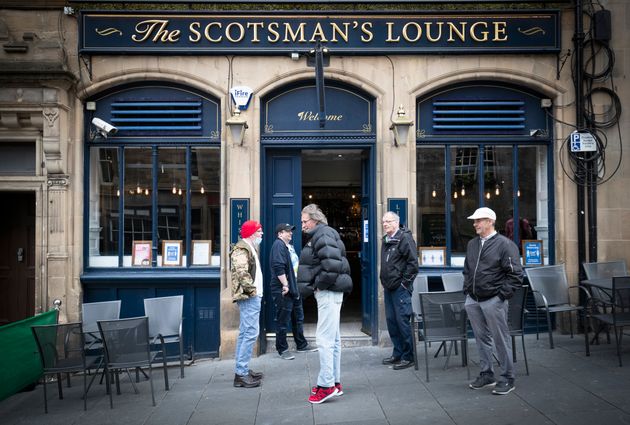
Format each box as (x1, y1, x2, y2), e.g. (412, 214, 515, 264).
(380, 211, 418, 370)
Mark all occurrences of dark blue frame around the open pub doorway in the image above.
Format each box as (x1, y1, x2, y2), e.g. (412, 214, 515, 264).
(259, 143, 378, 353)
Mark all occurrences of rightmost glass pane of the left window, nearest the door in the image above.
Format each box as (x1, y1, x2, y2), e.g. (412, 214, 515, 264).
(191, 148, 221, 266)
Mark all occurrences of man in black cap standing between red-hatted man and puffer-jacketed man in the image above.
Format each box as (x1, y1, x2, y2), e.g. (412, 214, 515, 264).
(269, 223, 317, 360)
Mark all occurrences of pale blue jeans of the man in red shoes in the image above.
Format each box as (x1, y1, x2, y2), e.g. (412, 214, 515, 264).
(315, 291, 343, 387)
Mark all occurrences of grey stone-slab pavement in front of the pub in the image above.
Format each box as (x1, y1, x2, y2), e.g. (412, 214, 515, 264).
(0, 334, 630, 425)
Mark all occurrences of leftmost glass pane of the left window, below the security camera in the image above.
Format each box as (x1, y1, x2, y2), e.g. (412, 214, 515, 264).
(88, 148, 120, 267)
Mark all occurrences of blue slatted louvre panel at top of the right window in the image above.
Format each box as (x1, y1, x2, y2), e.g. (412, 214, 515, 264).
(433, 100, 525, 131)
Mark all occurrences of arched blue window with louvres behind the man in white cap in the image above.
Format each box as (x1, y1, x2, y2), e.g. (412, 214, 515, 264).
(416, 82, 554, 267)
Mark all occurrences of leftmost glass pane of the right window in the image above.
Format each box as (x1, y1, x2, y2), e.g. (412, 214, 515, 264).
(416, 147, 446, 246)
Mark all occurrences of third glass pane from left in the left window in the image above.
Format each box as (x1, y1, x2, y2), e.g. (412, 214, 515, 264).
(158, 148, 187, 265)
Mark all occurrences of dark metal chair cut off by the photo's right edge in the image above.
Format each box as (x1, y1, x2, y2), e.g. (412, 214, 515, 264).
(586, 276, 630, 367)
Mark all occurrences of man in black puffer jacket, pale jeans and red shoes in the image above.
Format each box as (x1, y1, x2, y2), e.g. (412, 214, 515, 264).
(298, 204, 352, 404)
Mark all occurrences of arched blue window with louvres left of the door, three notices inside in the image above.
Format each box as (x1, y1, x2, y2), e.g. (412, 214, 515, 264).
(85, 84, 221, 268)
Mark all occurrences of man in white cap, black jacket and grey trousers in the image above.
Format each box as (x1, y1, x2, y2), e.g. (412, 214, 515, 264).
(464, 207, 523, 395)
